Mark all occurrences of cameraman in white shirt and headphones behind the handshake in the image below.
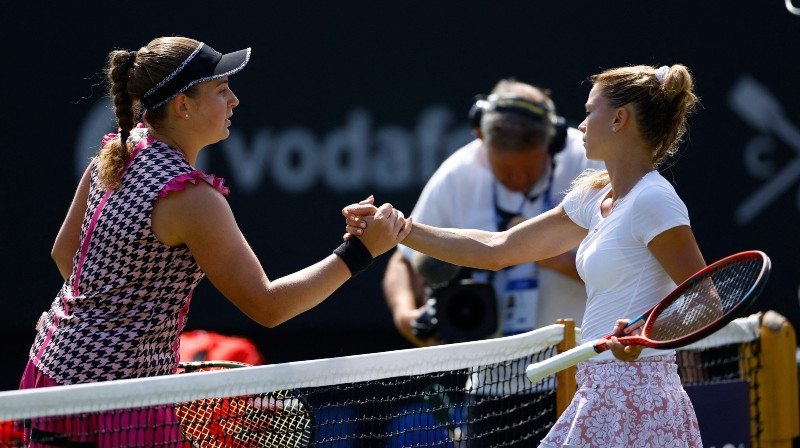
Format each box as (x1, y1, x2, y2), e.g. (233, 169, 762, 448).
(383, 79, 603, 346)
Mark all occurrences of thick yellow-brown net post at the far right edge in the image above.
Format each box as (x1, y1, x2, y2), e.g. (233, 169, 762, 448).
(755, 311, 800, 448)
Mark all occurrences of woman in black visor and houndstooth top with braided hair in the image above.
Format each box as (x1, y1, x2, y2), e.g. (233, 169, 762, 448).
(20, 37, 403, 446)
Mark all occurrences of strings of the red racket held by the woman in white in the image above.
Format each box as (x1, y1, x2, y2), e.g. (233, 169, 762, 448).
(644, 258, 764, 341)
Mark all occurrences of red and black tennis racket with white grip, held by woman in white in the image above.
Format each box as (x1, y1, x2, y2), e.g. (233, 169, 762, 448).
(525, 251, 771, 382)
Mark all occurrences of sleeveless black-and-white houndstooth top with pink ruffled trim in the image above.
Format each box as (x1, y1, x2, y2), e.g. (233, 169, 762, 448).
(30, 126, 228, 384)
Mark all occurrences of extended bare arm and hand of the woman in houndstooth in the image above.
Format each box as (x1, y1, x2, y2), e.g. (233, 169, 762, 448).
(153, 182, 408, 327)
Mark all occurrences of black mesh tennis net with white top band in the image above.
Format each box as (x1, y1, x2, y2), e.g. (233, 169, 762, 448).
(0, 315, 780, 448)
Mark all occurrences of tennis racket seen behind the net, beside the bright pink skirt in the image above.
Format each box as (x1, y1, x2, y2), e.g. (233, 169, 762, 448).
(175, 361, 314, 448)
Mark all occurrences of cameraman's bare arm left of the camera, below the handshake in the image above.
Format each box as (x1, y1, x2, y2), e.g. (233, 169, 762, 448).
(383, 250, 435, 347)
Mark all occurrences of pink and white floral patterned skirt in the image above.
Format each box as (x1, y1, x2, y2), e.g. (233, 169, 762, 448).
(539, 355, 703, 448)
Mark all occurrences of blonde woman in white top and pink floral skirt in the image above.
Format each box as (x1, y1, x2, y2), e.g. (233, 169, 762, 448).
(350, 65, 705, 448)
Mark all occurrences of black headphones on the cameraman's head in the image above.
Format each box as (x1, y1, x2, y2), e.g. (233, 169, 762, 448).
(469, 94, 568, 156)
